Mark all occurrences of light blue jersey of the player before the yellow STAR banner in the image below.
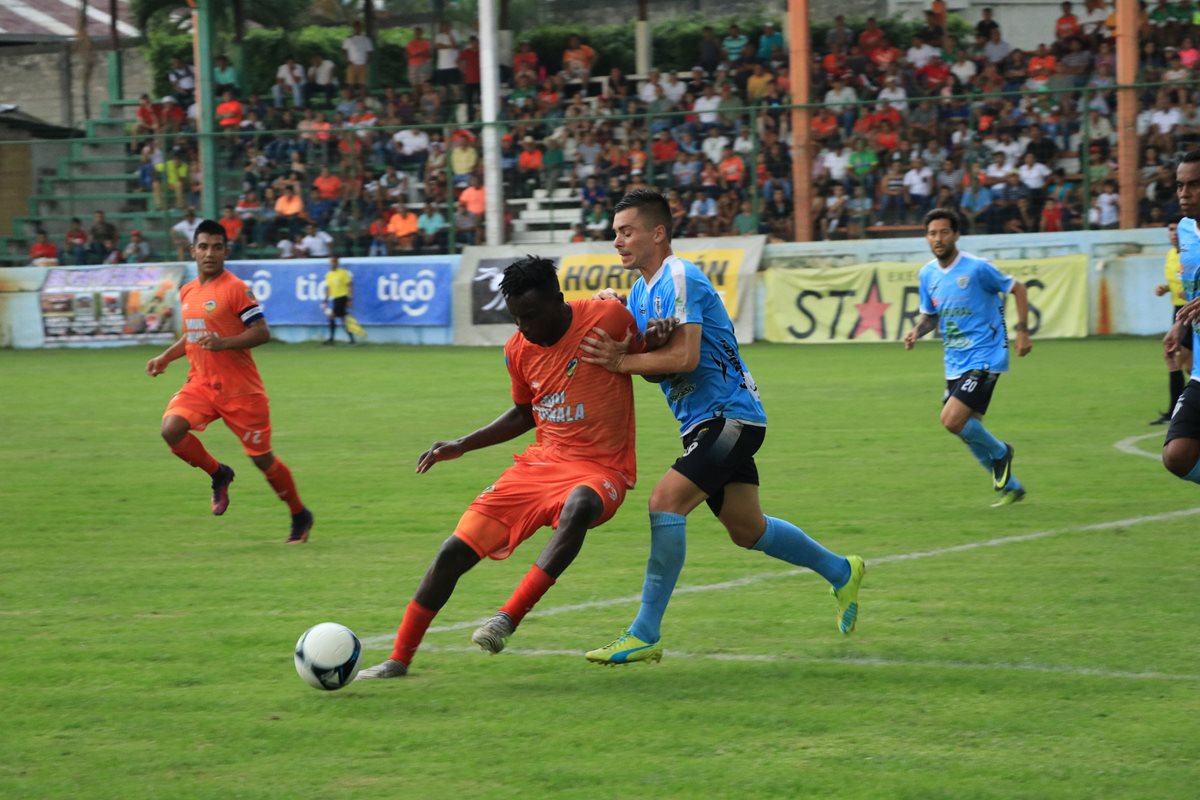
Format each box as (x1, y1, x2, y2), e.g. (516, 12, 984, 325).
(919, 251, 1016, 380)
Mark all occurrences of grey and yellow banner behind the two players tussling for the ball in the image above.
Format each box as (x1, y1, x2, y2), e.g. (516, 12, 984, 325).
(455, 236, 766, 344)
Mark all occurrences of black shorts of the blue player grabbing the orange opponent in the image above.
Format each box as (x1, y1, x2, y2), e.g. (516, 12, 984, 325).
(672, 419, 767, 515)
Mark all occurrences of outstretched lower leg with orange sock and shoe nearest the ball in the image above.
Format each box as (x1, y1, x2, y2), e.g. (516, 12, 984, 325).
(356, 535, 480, 680)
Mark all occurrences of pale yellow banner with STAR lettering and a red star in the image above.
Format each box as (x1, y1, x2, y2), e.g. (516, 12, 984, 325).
(763, 254, 1087, 343)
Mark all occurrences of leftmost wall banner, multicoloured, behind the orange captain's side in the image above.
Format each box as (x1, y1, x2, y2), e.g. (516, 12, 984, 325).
(41, 264, 184, 347)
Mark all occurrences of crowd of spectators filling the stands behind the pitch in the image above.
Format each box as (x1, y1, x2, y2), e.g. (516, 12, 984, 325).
(35, 0, 1200, 260)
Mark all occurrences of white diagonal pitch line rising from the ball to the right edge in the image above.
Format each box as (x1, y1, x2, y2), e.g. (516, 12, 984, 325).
(362, 507, 1200, 655)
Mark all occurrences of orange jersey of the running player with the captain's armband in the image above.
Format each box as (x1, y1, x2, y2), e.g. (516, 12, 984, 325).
(179, 272, 265, 397)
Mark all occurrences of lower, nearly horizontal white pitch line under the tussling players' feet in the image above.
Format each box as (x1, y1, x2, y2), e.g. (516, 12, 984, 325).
(421, 644, 1200, 681)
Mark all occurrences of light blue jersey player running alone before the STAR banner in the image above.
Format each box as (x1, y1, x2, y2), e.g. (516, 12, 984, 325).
(904, 209, 1033, 506)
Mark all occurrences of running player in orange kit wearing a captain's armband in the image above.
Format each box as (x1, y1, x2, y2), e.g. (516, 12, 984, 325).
(146, 219, 312, 545)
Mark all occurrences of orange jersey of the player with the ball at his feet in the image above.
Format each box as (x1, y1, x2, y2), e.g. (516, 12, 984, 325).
(504, 300, 644, 488)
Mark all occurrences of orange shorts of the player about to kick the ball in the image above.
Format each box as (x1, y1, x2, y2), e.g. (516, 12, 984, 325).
(454, 462, 626, 560)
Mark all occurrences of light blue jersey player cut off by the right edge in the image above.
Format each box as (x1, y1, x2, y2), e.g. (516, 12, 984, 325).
(1163, 150, 1200, 483)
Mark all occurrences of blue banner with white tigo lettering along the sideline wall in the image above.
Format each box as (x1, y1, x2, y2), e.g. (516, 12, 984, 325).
(228, 257, 457, 326)
